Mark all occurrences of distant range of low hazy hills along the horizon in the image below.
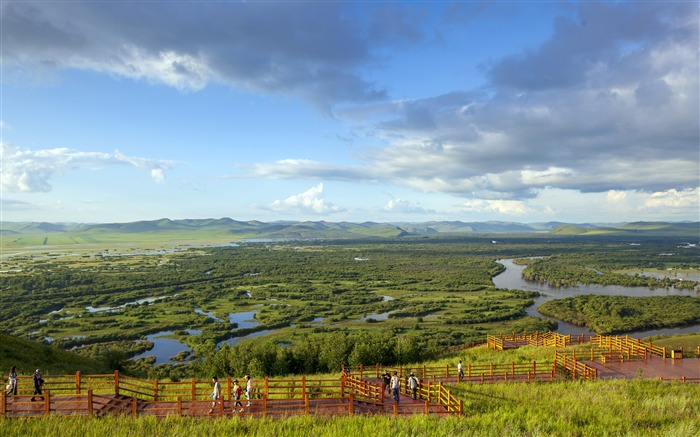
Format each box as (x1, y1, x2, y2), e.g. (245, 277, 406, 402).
(0, 218, 700, 246)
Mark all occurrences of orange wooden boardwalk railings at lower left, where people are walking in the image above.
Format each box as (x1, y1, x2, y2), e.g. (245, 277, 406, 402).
(0, 372, 461, 417)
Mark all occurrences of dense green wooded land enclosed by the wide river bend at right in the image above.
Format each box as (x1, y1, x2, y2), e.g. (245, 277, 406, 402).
(539, 294, 700, 334)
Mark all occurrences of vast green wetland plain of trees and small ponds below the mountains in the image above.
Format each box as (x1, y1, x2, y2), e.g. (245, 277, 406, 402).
(0, 234, 700, 379)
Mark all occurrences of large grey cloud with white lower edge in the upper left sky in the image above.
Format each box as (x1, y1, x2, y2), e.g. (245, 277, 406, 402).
(2, 1, 392, 107)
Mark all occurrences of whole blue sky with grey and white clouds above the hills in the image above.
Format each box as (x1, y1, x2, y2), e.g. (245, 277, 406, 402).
(0, 0, 700, 223)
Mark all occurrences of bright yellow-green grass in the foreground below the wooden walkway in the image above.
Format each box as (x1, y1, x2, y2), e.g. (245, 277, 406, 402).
(0, 380, 700, 437)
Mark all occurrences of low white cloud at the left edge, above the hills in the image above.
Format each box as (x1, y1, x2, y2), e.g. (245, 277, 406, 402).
(0, 142, 172, 193)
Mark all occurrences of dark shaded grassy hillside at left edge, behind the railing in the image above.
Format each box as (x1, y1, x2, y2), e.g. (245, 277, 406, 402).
(0, 333, 110, 377)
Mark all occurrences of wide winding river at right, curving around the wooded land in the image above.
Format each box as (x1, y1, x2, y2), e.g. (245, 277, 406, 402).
(493, 259, 700, 337)
